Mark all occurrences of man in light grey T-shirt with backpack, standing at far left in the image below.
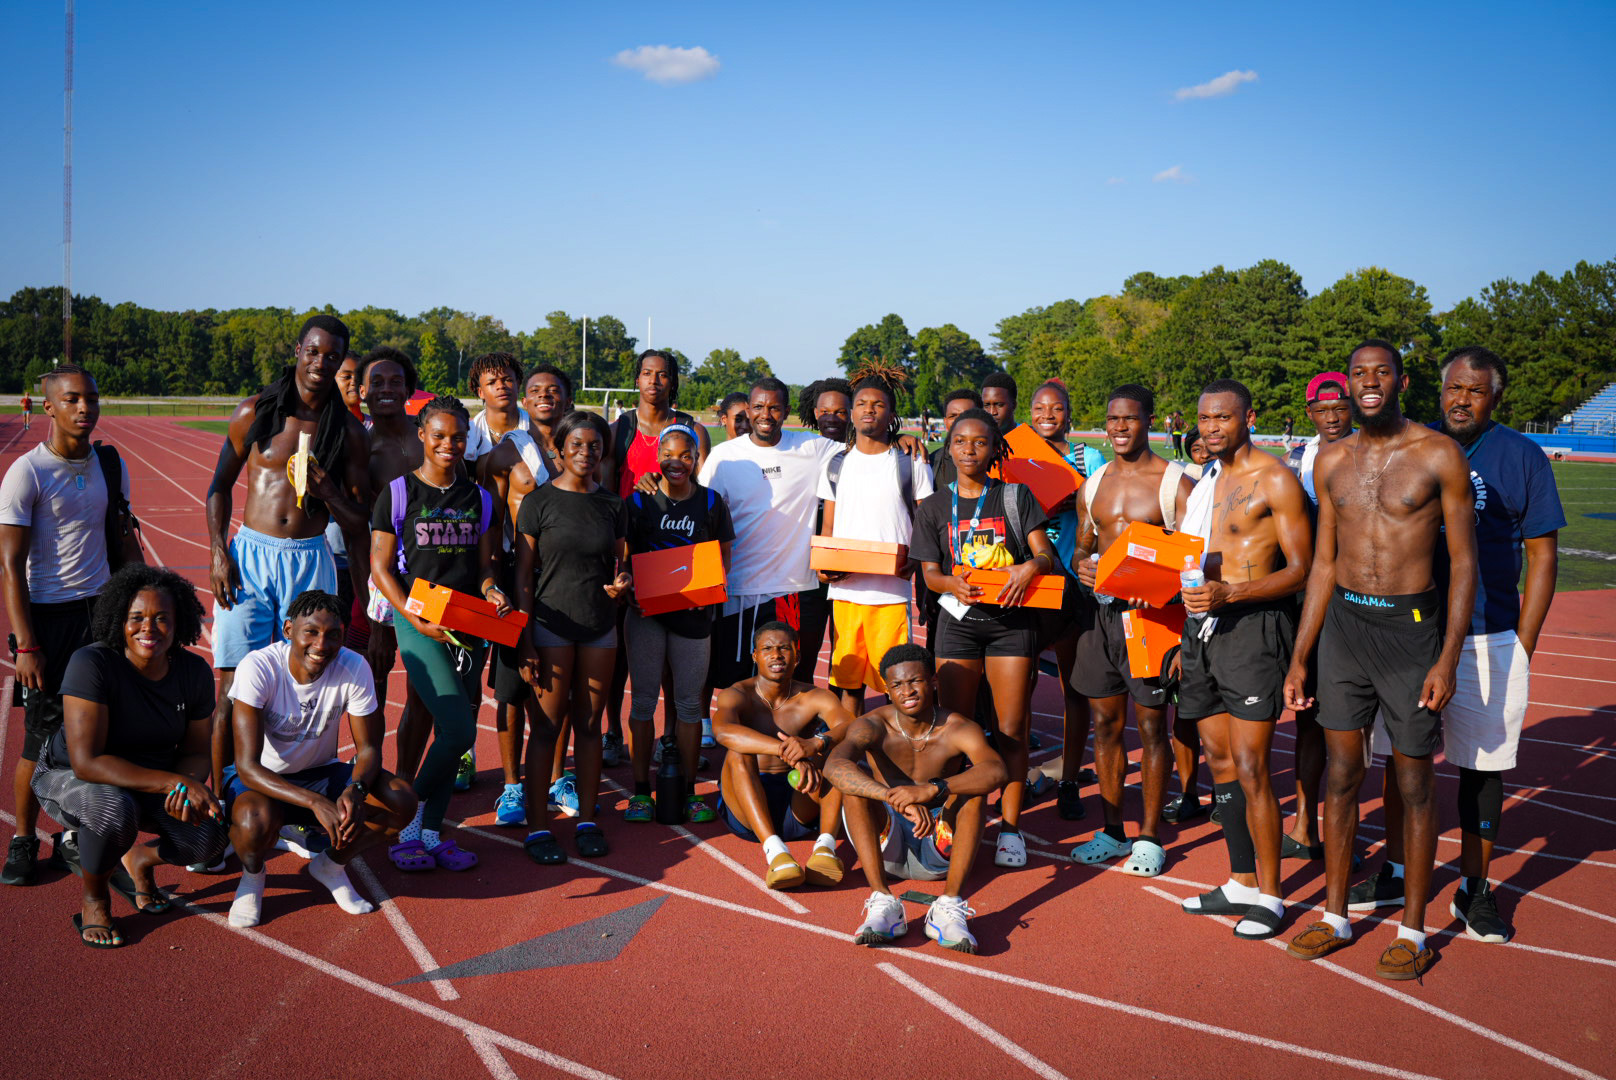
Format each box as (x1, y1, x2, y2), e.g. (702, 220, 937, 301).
(0, 365, 145, 884)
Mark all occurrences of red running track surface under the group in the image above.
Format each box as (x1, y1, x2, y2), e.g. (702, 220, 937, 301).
(0, 417, 1616, 1080)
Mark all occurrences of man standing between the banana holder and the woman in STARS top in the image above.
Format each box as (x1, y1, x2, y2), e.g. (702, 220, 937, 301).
(349, 346, 431, 776)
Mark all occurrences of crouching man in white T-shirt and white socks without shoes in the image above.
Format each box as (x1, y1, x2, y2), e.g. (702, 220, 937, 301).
(223, 590, 415, 926)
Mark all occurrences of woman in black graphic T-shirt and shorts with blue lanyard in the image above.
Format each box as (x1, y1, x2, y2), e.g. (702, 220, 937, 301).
(910, 409, 1057, 867)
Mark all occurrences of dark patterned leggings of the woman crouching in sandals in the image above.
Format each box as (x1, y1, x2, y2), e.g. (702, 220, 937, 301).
(32, 765, 229, 875)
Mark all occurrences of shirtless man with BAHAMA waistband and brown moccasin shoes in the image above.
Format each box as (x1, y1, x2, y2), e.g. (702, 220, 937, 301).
(1285, 340, 1475, 980)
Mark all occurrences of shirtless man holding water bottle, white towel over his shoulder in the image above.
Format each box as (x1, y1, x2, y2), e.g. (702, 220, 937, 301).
(1178, 378, 1312, 939)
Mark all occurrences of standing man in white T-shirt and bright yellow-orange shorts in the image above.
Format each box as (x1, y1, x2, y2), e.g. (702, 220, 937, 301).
(819, 377, 931, 716)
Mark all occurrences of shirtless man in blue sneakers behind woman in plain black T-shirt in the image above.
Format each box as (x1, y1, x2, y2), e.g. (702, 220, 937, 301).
(477, 364, 572, 826)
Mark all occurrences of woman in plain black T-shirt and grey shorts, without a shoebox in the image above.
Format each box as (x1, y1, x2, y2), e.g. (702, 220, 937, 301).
(516, 411, 630, 865)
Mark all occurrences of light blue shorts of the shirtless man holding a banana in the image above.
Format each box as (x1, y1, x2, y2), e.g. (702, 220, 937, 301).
(213, 525, 336, 671)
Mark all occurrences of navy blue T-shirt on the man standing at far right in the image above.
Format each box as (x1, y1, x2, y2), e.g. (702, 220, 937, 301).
(1430, 424, 1566, 634)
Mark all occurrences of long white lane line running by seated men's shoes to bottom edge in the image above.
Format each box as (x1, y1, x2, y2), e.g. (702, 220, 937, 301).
(446, 818, 1467, 1080)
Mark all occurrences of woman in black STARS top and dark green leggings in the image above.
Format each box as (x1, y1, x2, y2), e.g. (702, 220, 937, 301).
(370, 396, 511, 870)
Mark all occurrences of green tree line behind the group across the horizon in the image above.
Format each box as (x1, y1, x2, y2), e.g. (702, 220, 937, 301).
(0, 259, 1616, 430)
